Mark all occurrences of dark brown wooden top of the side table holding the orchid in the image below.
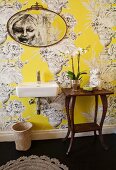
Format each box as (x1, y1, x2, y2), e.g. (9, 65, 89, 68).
(62, 88, 114, 96)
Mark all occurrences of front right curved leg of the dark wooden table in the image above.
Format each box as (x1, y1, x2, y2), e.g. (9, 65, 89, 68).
(98, 95, 108, 150)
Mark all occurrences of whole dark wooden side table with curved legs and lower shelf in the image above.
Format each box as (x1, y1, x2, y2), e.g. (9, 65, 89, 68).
(62, 88, 114, 154)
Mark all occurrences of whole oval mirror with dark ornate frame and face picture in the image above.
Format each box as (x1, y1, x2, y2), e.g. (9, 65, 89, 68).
(7, 4, 67, 47)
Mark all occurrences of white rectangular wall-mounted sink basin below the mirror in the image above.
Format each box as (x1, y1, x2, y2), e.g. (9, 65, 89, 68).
(16, 82, 59, 97)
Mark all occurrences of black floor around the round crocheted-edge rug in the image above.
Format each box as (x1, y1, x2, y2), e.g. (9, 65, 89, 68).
(0, 134, 116, 170)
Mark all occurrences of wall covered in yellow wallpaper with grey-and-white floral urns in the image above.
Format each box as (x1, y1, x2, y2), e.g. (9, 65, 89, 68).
(0, 0, 116, 136)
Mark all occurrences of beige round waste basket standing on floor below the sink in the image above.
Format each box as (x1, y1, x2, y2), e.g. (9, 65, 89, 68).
(12, 122, 32, 151)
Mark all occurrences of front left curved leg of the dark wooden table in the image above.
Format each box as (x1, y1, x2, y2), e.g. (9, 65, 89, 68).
(66, 96, 76, 155)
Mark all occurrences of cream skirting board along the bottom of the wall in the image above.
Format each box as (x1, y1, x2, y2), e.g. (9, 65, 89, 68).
(0, 125, 116, 142)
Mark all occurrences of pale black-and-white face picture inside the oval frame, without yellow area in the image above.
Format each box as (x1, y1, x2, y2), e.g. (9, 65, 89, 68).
(8, 10, 66, 47)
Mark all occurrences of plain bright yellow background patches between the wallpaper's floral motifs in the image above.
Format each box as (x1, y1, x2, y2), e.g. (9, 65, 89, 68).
(0, 0, 114, 130)
